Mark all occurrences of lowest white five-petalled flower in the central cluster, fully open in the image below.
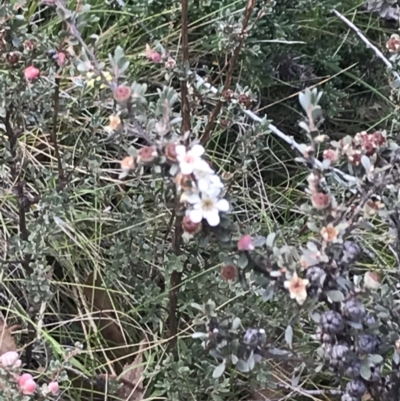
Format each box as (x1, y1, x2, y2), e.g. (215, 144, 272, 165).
(186, 193, 229, 227)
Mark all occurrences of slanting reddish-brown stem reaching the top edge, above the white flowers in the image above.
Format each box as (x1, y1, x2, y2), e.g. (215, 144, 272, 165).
(200, 0, 255, 145)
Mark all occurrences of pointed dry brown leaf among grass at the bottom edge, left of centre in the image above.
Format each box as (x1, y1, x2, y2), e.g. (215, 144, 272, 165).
(118, 340, 147, 401)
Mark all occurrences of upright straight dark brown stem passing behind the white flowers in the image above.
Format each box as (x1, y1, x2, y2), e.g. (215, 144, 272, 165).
(169, 0, 190, 347)
